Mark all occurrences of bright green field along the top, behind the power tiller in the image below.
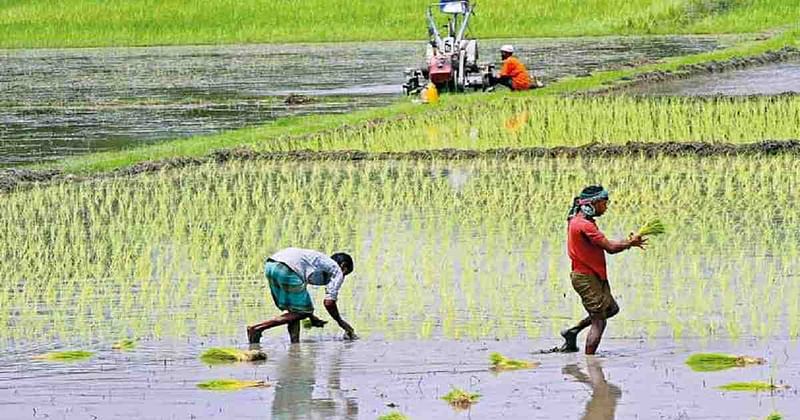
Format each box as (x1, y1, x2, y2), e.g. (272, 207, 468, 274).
(0, 0, 800, 48)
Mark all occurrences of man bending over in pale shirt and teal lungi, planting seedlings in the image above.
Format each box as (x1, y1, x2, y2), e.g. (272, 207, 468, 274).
(247, 248, 357, 344)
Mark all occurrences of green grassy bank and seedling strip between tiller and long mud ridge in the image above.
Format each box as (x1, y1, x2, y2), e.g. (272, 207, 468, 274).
(45, 29, 800, 174)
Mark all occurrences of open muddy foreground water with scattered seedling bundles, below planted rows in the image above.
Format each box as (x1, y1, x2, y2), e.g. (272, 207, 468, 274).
(0, 338, 800, 419)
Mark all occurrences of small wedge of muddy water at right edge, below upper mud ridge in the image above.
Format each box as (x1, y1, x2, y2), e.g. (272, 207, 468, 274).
(631, 62, 800, 96)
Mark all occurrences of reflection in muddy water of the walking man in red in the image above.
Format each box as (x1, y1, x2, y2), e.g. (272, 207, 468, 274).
(561, 356, 622, 420)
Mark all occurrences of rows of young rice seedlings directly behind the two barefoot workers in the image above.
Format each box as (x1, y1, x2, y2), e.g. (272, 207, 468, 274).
(0, 156, 800, 343)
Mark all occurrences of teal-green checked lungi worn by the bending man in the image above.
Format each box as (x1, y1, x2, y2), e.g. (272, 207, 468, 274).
(264, 261, 314, 313)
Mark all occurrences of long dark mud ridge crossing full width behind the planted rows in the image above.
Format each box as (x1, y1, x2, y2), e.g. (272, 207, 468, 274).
(0, 140, 800, 193)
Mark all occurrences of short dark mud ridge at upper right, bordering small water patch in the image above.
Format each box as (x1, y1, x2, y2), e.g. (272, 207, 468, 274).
(600, 46, 800, 95)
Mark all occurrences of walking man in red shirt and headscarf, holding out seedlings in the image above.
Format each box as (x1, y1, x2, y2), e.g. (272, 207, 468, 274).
(560, 185, 647, 354)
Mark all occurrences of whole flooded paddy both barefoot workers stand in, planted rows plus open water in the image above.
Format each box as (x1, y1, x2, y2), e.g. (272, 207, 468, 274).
(0, 156, 800, 419)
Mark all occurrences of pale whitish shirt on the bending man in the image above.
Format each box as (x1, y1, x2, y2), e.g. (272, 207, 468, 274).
(269, 248, 344, 300)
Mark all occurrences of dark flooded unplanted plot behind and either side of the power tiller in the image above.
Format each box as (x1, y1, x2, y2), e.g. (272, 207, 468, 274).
(0, 37, 736, 166)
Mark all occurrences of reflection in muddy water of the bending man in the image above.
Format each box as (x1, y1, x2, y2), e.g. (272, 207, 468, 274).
(272, 343, 358, 420)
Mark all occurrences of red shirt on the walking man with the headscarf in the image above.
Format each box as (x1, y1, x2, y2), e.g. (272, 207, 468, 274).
(567, 213, 608, 280)
